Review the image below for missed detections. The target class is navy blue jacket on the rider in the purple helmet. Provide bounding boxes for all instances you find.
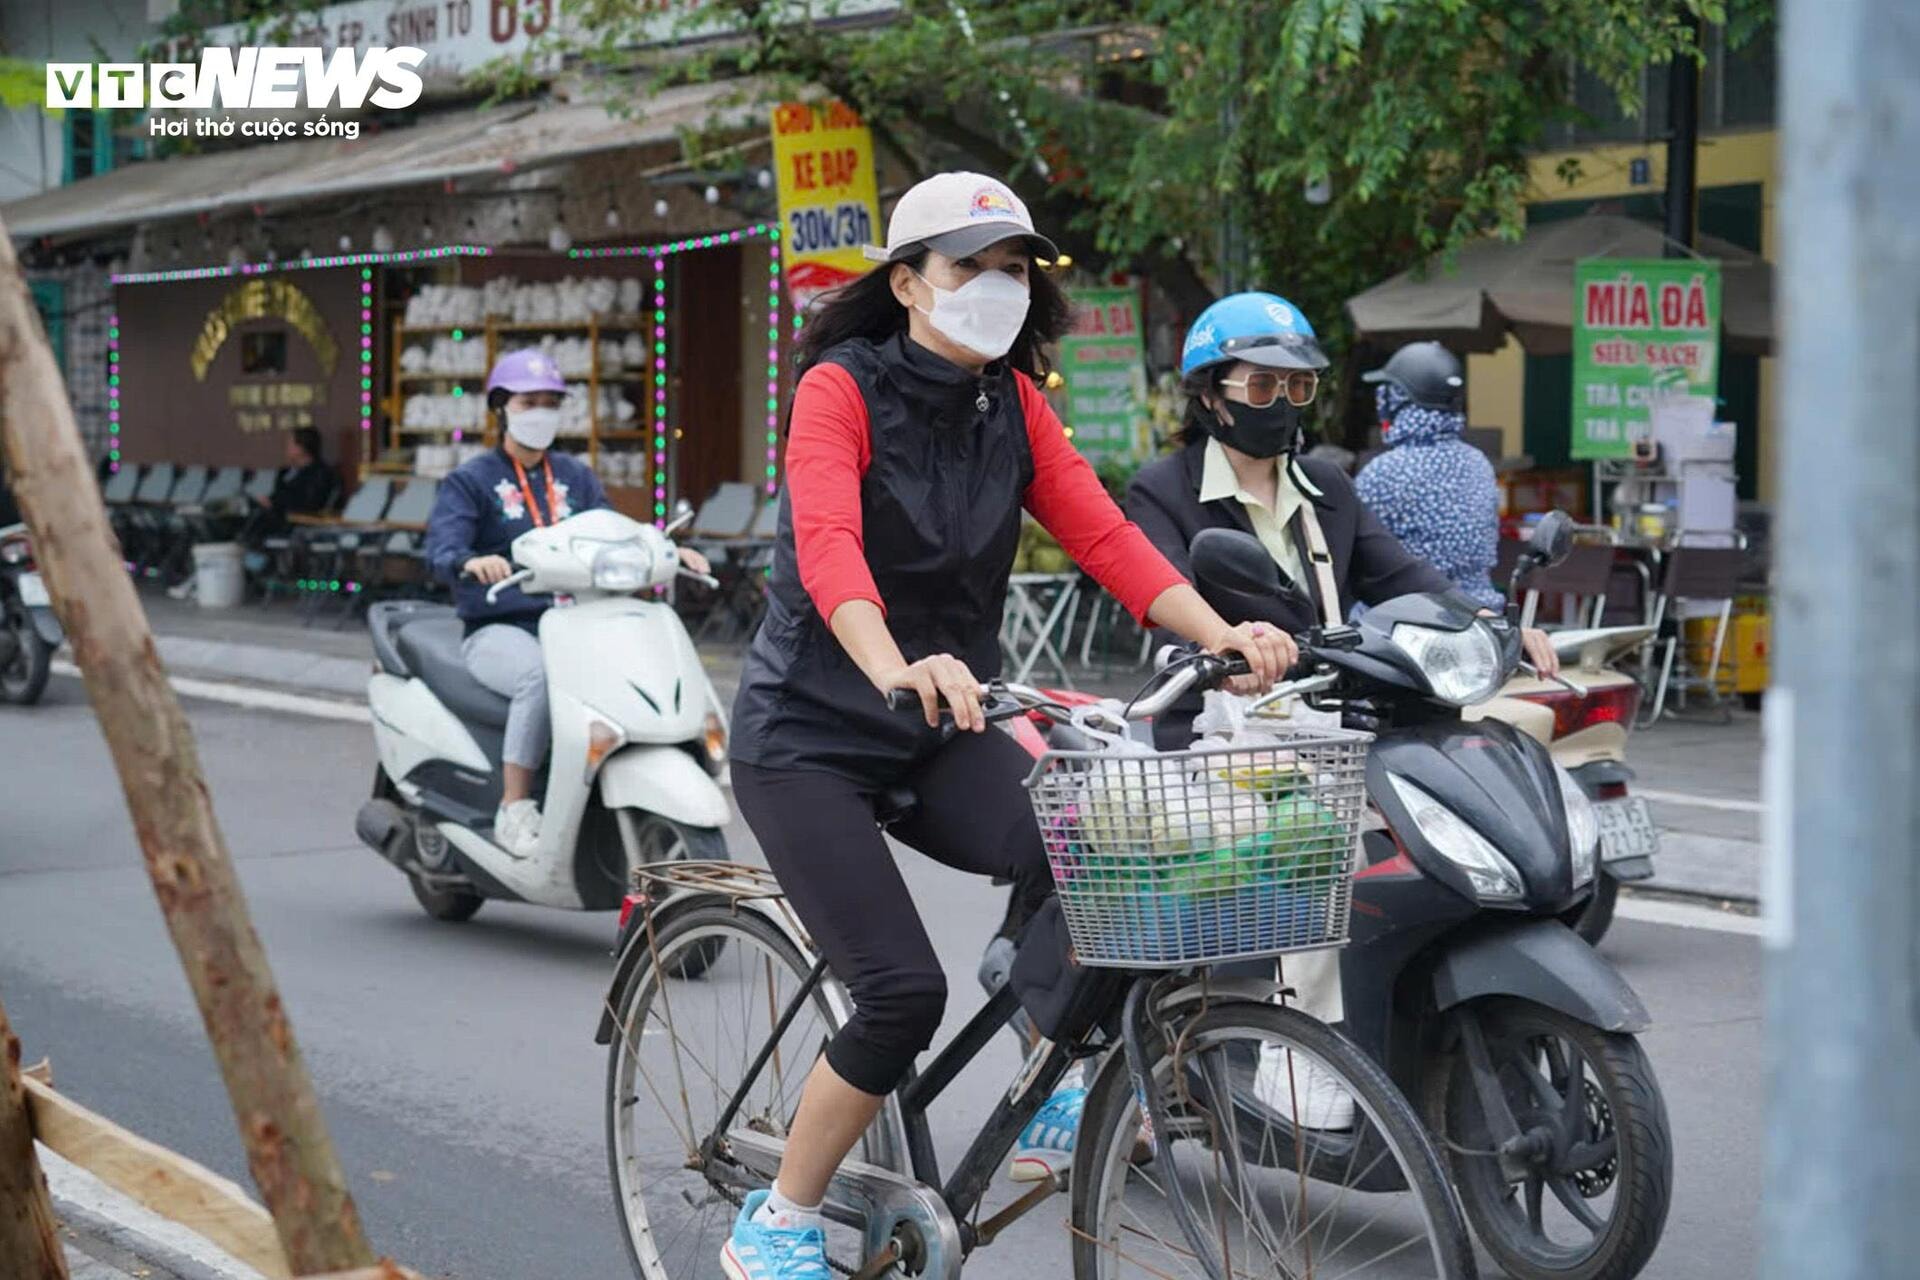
[426,449,607,635]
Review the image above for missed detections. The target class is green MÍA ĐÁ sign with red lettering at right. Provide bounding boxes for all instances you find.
[1572,257,1720,459]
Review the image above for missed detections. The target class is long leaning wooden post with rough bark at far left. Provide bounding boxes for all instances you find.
[0,226,374,1274]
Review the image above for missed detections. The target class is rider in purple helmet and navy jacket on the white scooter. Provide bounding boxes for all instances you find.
[426,351,707,858]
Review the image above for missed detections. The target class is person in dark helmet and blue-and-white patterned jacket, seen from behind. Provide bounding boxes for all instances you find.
[1354,342,1505,608]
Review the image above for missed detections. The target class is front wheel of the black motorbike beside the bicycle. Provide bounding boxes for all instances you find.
[1427,1000,1672,1280]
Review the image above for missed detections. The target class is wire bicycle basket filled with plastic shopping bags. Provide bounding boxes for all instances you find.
[1027,725,1373,969]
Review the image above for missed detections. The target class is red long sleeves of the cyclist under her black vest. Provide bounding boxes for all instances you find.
[787,365,1187,622]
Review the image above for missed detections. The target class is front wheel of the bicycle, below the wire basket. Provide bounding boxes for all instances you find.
[1071,1002,1475,1280]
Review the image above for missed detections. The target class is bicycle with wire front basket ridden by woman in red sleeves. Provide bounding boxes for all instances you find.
[597,654,1476,1280]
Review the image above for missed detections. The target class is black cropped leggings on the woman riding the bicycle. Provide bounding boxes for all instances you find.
[733,729,1054,1094]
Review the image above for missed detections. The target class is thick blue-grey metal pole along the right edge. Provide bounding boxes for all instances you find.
[1761,0,1920,1280]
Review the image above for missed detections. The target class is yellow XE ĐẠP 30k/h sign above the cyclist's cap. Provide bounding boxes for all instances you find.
[774,102,881,313]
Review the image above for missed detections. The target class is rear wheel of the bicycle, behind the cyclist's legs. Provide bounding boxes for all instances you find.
[607,904,904,1280]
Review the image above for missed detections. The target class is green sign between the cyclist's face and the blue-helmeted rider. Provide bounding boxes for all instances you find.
[1060,288,1148,462]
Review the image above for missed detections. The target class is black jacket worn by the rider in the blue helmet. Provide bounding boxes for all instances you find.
[1127,439,1453,747]
